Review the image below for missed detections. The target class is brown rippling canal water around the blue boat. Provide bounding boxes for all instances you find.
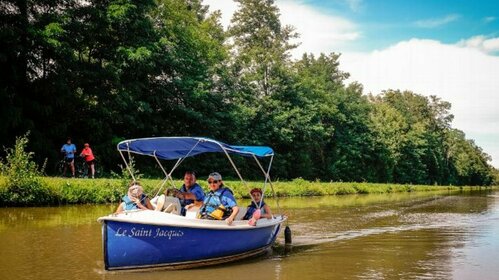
[0,190,499,280]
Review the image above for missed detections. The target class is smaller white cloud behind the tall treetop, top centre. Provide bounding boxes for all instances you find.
[203,0,361,57]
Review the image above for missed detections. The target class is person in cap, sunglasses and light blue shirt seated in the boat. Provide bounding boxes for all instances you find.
[199,172,239,225]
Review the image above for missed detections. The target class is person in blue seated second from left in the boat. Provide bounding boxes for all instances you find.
[155,171,204,216]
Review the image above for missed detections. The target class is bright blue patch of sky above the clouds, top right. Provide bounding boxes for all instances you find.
[296,0,499,54]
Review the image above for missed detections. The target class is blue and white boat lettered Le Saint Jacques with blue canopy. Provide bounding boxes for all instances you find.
[98,137,287,270]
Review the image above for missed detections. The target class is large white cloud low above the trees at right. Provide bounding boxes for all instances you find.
[341,39,499,167]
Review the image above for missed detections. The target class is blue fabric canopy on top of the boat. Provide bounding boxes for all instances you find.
[118,137,274,160]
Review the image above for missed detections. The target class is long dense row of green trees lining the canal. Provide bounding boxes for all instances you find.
[0,0,497,185]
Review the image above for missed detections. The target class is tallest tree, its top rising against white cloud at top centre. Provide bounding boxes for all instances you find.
[228,0,297,98]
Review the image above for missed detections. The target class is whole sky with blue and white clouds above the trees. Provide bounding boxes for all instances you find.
[204,0,499,168]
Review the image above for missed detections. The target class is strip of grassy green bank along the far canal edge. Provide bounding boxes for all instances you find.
[0,176,496,206]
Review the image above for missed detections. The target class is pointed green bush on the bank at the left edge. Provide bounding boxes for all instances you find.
[0,133,53,205]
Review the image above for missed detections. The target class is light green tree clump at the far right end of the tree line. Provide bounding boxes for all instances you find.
[371,90,491,185]
